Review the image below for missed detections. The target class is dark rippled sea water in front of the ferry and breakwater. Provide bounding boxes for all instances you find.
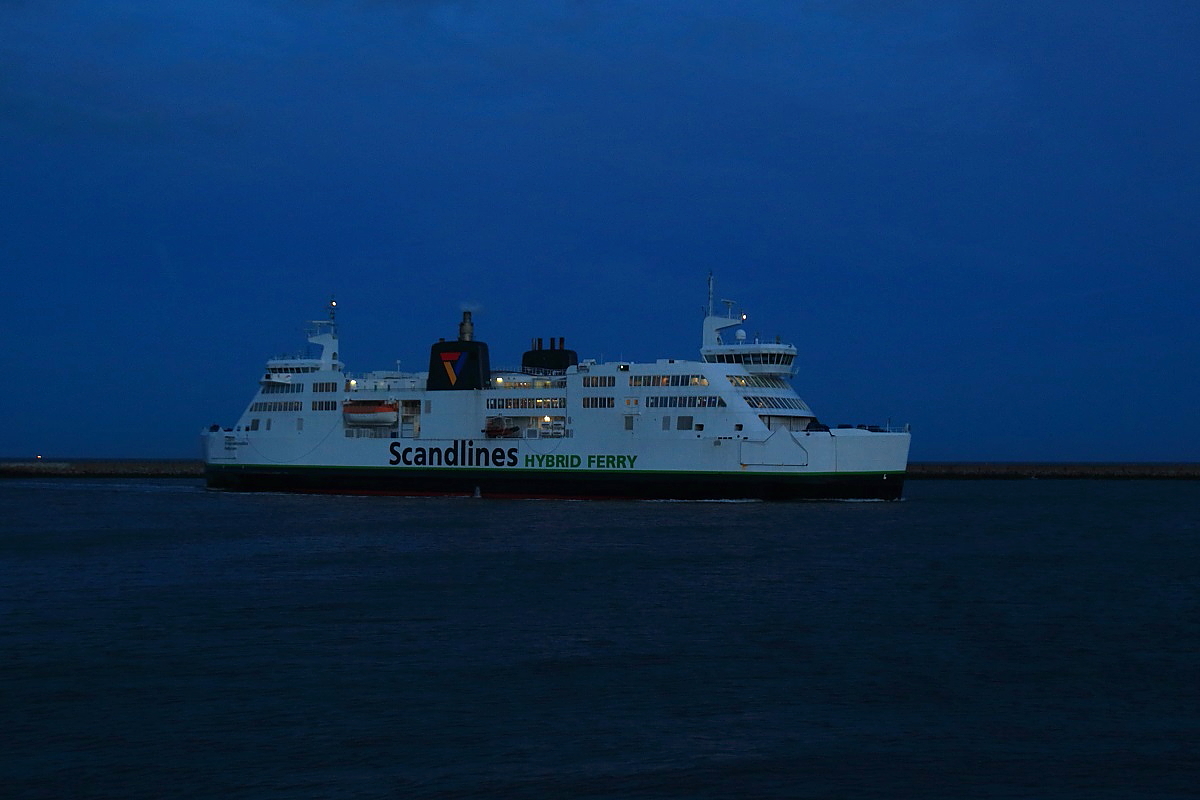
[0,480,1200,800]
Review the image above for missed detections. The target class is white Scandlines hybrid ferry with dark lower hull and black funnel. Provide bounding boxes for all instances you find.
[202,276,910,500]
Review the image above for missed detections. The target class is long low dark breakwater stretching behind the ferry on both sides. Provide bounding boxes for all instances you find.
[0,458,1200,480]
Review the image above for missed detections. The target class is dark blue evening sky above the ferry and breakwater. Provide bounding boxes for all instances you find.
[0,0,1200,461]
